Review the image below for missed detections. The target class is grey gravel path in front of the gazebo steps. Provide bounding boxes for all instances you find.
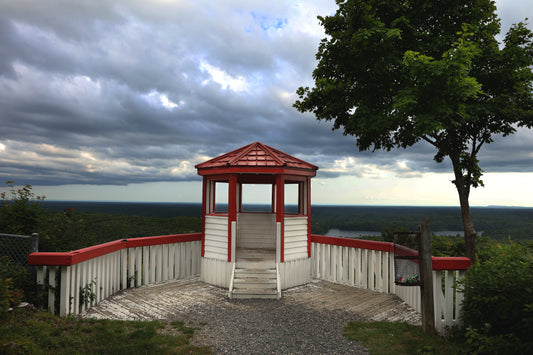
[189,299,367,354]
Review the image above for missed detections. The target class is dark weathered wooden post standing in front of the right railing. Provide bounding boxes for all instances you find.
[420,217,436,334]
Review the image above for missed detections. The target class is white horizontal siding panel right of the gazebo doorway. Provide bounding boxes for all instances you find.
[284,217,308,261]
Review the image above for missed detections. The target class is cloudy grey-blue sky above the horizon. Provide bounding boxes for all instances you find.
[0,0,533,206]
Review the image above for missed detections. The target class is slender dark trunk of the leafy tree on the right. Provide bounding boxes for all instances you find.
[452,158,476,262]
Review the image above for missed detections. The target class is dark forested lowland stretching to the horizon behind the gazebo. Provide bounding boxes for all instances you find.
[44,201,533,240]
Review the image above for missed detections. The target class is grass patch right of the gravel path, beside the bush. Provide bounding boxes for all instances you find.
[344,322,455,355]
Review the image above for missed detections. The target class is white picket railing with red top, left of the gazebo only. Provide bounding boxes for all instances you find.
[28,233,201,316]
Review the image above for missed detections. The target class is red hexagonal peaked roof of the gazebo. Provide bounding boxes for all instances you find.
[195,142,318,176]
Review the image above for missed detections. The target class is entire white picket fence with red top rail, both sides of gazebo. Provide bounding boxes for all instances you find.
[28,233,469,334]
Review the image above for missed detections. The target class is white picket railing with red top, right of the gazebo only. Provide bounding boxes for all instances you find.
[311,235,471,334]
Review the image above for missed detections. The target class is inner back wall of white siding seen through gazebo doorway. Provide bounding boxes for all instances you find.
[237,213,276,249]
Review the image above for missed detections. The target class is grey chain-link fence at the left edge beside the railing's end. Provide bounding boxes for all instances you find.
[0,233,39,266]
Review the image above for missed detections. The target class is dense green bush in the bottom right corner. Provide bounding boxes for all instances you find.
[456,242,533,354]
